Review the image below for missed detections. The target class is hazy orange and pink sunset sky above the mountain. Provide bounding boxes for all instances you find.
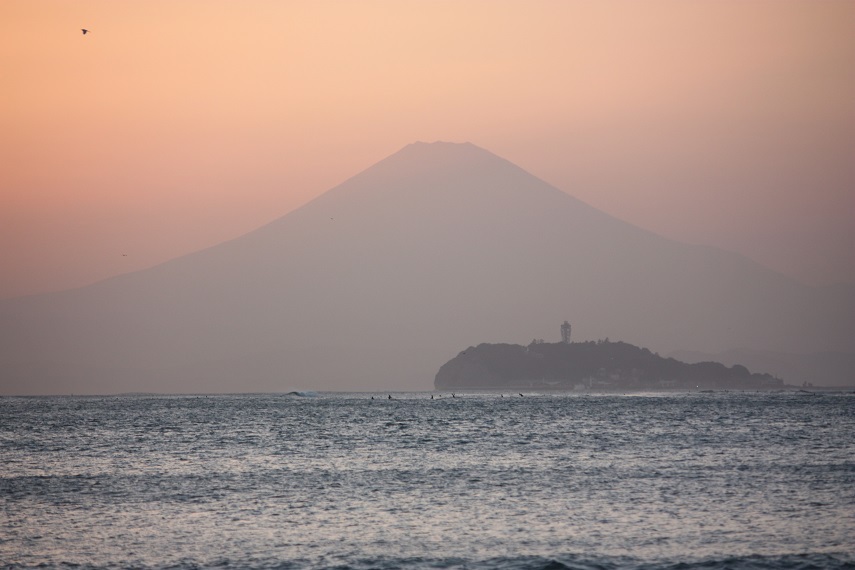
[0,0,855,298]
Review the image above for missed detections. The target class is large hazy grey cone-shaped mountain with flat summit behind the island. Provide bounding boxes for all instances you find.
[0,143,855,393]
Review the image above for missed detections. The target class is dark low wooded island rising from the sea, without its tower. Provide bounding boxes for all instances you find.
[434,340,782,390]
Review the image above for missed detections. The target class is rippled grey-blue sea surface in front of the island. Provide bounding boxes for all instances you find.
[0,392,855,569]
